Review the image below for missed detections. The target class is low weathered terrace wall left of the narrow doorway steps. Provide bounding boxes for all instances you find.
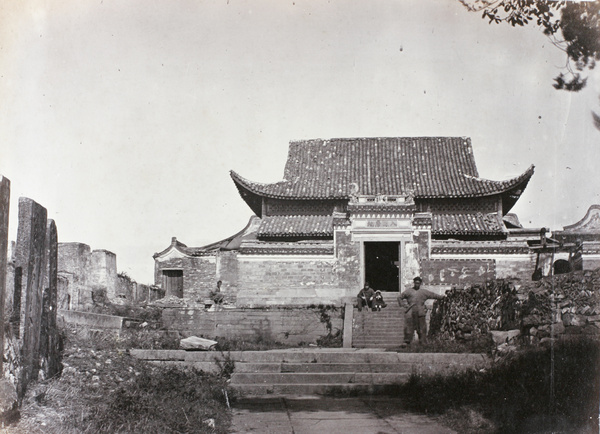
[163,308,343,345]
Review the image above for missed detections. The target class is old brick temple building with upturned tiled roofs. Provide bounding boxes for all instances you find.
[154,137,539,306]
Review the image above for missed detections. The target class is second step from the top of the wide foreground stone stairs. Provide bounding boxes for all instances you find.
[235,363,413,373]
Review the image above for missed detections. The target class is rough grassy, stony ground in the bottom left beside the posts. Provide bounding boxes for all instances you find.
[3,328,231,434]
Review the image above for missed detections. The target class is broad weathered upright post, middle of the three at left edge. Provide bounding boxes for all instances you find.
[15,197,47,399]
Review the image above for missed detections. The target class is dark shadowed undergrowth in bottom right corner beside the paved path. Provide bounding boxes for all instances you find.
[398,339,600,432]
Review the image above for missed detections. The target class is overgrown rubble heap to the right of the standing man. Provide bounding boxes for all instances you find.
[430,269,600,341]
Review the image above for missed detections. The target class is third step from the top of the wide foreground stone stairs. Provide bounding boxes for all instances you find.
[230,372,410,386]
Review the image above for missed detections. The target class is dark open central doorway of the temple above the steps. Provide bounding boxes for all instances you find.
[365,242,400,292]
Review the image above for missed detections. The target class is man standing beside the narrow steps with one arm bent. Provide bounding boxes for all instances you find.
[398,276,444,345]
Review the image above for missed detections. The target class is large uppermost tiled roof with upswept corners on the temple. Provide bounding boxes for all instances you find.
[231,137,533,199]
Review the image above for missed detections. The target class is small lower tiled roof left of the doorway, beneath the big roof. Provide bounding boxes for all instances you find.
[256,215,333,238]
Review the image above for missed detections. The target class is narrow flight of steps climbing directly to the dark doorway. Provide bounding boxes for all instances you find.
[352,292,404,349]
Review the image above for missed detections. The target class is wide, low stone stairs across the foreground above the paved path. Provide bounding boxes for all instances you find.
[131,348,489,396]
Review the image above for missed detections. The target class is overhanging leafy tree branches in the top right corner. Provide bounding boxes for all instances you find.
[460,0,600,92]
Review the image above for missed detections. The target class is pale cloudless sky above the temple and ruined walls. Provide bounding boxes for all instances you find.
[0,0,600,283]
